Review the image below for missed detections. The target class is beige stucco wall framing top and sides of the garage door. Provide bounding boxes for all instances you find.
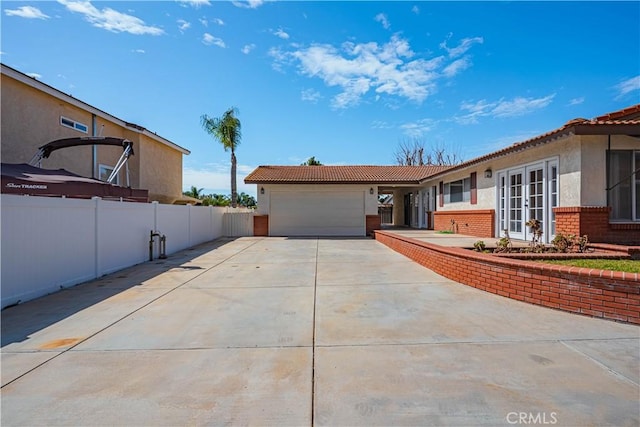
[256,184,378,215]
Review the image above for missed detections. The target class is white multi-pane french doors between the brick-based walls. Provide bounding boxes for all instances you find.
[498,160,558,243]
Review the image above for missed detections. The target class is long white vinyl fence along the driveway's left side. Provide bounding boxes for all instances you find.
[0,194,253,308]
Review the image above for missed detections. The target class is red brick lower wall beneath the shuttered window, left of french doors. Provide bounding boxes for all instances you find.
[433,209,496,237]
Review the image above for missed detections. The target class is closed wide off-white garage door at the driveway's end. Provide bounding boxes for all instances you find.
[269,191,365,236]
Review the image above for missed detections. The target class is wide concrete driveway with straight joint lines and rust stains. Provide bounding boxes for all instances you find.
[0,238,640,426]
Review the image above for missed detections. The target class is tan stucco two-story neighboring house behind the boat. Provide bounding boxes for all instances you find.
[0,64,189,203]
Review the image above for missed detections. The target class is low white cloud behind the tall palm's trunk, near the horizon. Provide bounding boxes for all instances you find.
[182,163,256,196]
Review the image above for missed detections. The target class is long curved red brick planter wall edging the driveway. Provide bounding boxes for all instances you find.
[375,231,640,324]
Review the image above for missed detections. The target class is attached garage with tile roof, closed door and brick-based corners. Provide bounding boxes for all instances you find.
[245,166,444,236]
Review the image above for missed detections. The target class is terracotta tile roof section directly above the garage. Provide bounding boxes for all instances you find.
[244,166,450,184]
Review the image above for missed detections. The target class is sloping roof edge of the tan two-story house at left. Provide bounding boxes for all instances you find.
[1,64,191,154]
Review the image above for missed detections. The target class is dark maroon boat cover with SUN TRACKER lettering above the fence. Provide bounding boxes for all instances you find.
[1,164,149,203]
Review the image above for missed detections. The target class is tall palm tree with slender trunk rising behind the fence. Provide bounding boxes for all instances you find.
[200,107,242,208]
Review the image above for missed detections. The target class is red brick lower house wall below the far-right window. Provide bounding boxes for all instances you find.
[553,206,640,245]
